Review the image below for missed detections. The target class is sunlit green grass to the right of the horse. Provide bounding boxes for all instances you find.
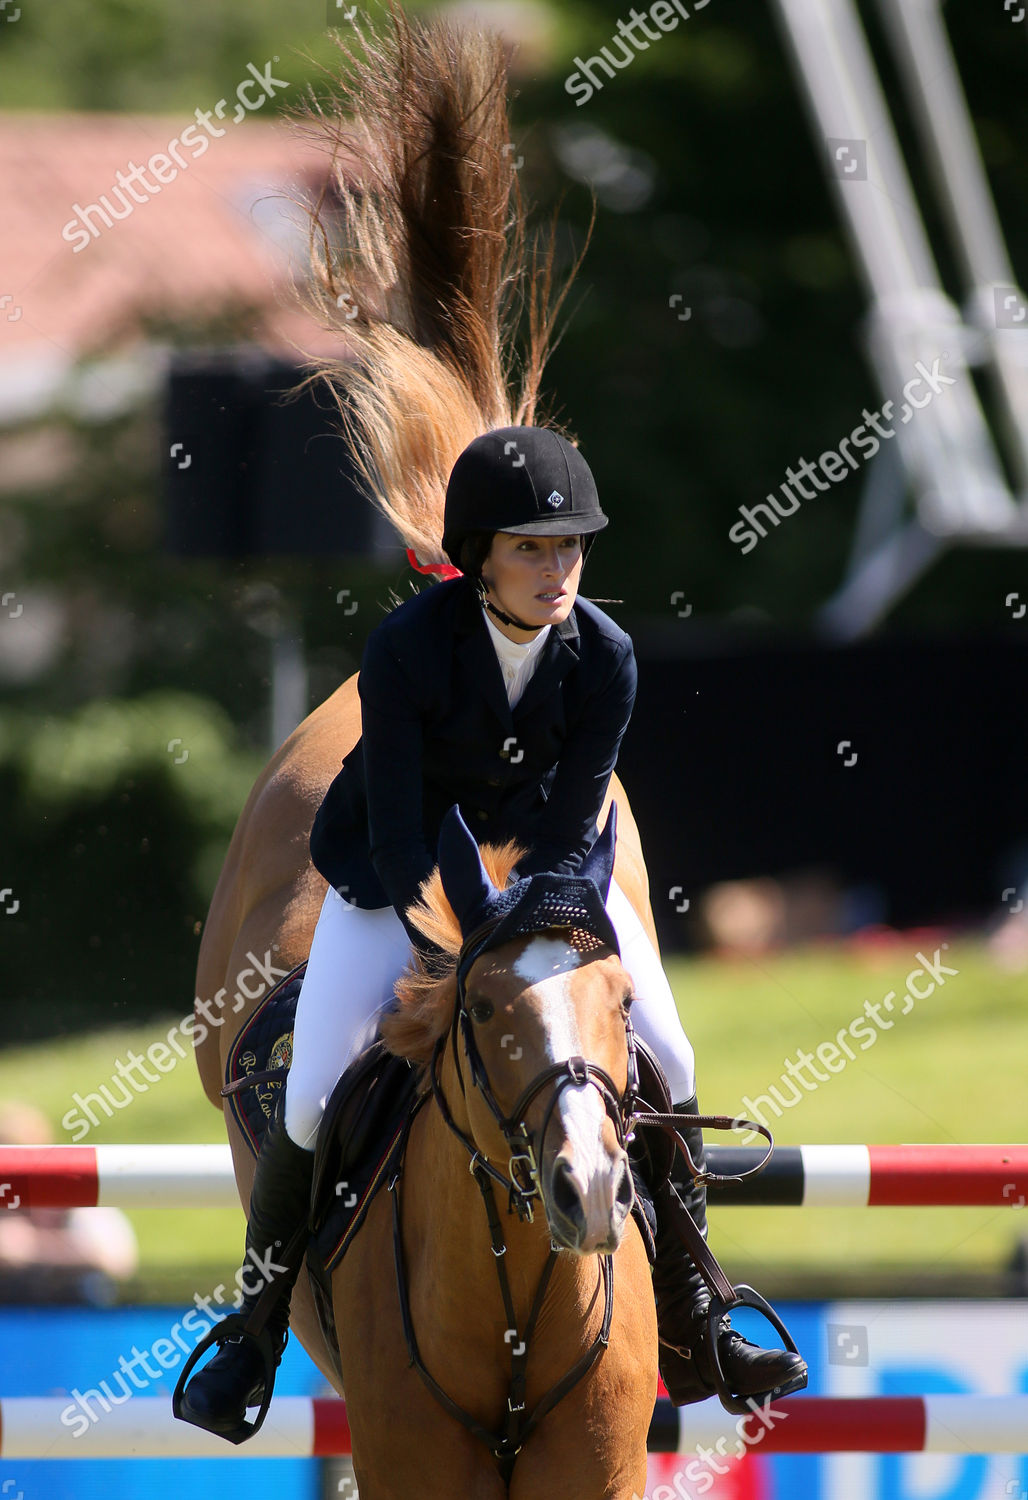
[671,936,1028,1280]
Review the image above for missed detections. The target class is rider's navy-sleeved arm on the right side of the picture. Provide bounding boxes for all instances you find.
[518,636,638,875]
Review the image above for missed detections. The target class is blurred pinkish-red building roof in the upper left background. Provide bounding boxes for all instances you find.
[0,113,348,422]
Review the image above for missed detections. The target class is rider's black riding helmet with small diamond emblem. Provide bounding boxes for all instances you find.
[443,428,606,569]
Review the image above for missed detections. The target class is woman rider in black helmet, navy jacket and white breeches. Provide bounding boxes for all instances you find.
[174,426,804,1434]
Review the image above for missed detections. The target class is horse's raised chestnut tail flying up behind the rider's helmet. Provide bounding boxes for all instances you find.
[297,0,591,563]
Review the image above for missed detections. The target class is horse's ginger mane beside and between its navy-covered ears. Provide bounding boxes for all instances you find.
[381,842,525,1065]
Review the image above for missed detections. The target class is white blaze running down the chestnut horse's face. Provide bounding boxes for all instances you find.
[513,938,621,1242]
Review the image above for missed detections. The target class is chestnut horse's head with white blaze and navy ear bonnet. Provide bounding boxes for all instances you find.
[438,807,636,1254]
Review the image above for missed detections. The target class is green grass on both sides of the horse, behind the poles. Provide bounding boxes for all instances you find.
[0,936,1028,1295]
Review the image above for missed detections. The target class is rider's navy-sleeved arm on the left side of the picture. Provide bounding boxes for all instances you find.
[357,633,435,953]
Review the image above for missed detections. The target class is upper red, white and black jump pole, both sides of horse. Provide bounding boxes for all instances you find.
[0,1145,1028,1209]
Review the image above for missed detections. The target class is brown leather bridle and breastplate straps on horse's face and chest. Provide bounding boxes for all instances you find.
[389,920,639,1482]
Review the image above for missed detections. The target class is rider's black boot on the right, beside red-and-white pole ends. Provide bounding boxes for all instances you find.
[653,1095,807,1406]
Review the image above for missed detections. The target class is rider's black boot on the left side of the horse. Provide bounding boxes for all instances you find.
[176,1103,314,1442]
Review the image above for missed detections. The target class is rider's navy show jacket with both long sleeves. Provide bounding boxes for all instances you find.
[311,578,636,947]
